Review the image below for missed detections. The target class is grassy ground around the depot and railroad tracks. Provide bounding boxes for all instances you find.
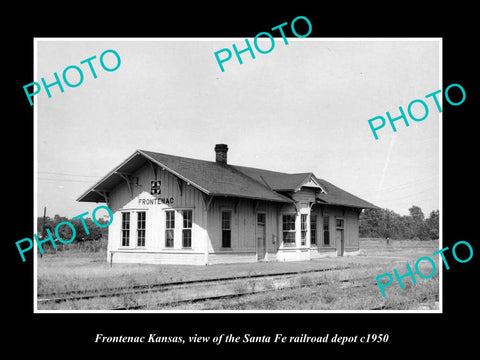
[37,239,439,310]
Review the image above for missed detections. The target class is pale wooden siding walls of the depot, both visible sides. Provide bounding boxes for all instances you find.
[107,164,359,264]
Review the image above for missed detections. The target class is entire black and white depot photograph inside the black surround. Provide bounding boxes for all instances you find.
[32,37,438,313]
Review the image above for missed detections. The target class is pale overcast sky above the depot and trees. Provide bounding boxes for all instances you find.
[32,38,441,217]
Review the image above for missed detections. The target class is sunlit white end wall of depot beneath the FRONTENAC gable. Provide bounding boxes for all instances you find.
[107,164,208,263]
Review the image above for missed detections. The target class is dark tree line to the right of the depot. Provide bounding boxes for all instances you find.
[359,205,439,240]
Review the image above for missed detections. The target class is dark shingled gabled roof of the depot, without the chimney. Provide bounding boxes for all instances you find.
[77,150,377,208]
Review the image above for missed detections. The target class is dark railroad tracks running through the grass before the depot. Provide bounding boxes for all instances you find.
[37,266,351,304]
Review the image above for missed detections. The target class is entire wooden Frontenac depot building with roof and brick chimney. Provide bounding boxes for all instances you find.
[77,144,376,265]
